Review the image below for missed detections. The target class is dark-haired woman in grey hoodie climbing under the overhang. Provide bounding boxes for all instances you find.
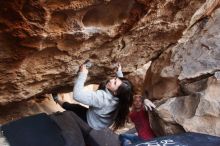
[53,64,133,130]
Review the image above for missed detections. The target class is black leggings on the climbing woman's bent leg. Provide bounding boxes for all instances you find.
[62,102,88,123]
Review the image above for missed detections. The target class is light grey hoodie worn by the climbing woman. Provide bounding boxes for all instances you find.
[73,71,123,130]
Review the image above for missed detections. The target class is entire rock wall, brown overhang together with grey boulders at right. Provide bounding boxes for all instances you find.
[0,0,220,138]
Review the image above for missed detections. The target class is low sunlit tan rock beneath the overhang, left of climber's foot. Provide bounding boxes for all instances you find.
[0,96,64,125]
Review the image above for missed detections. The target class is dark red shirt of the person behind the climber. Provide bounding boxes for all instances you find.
[129,108,155,140]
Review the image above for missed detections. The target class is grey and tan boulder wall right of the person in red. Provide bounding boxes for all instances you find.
[145,0,220,136]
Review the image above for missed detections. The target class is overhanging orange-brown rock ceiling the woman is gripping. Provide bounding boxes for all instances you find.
[0,0,204,104]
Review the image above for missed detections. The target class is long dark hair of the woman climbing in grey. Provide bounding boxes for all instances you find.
[113,78,133,130]
